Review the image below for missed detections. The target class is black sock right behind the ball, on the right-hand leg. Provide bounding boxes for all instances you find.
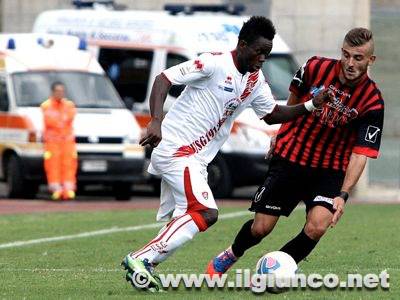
[280,228,318,263]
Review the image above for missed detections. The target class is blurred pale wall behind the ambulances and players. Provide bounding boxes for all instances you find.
[0,0,400,193]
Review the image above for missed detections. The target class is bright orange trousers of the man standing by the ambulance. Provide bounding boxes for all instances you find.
[44,141,78,192]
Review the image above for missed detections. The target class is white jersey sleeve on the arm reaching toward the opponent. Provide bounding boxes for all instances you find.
[250,76,276,119]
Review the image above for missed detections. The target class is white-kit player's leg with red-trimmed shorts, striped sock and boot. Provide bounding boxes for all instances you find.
[123,164,218,290]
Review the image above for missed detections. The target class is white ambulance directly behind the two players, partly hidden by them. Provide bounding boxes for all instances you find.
[33,1,297,197]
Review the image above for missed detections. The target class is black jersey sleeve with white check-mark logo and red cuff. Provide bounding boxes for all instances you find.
[353,109,384,158]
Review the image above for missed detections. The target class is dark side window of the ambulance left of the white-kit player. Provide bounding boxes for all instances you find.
[99,48,153,104]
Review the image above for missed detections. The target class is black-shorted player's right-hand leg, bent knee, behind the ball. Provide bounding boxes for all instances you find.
[280,170,344,263]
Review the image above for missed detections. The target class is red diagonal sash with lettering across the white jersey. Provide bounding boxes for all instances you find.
[173,72,258,157]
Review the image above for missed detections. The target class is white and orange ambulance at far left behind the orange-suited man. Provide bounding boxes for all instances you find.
[0,33,145,200]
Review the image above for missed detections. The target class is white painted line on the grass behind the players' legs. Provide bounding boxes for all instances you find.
[0,211,250,249]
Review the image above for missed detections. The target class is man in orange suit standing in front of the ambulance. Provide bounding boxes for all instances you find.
[41,82,78,200]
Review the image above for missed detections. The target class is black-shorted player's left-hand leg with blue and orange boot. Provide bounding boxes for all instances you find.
[206,159,299,274]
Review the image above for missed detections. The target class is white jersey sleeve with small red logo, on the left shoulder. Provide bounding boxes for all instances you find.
[163,53,216,86]
